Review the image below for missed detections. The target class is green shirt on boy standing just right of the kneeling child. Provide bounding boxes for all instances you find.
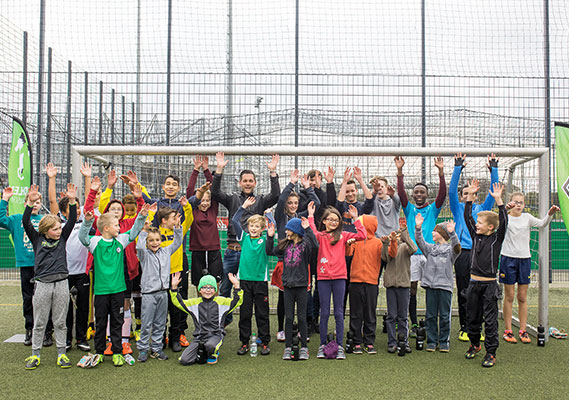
[238,232,269,282]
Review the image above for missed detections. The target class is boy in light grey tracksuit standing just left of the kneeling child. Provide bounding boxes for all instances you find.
[136,227,183,362]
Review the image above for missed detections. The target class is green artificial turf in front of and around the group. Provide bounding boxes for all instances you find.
[0,283,569,399]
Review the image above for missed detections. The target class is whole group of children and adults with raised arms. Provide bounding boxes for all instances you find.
[0,153,558,369]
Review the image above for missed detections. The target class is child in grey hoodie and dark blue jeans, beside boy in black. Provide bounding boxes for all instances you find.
[415,214,461,353]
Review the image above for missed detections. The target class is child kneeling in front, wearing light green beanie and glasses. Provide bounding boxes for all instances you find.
[170,272,243,365]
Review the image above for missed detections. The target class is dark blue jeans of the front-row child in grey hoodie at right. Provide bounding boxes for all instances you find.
[425,288,452,349]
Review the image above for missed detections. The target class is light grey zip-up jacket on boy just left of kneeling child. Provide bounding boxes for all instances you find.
[136,228,183,294]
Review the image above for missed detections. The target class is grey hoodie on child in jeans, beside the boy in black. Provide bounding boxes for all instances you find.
[415,226,460,292]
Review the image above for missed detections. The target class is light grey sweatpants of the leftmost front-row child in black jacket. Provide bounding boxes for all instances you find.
[32,279,69,356]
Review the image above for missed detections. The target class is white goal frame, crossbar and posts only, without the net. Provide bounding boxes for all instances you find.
[71,145,551,334]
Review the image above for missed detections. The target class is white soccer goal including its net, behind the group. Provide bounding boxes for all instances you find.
[72,143,560,340]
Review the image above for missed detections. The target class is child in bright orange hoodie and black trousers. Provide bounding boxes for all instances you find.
[348,215,397,354]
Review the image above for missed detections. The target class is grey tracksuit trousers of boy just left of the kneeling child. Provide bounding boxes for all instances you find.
[136,290,168,351]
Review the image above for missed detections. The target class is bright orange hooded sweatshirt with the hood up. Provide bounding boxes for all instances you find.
[350,215,397,285]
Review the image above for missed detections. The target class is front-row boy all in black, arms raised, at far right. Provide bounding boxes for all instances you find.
[463,179,508,367]
